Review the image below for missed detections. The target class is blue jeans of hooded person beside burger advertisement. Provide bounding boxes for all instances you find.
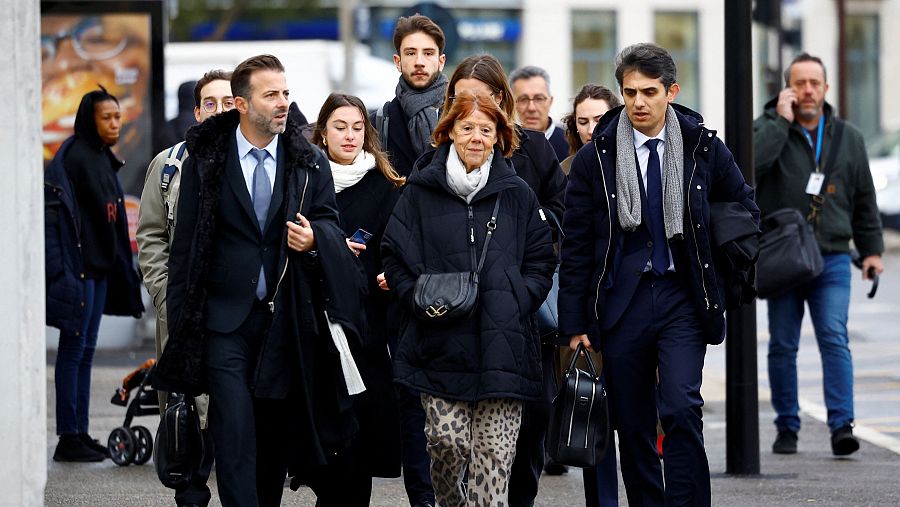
[54,278,106,435]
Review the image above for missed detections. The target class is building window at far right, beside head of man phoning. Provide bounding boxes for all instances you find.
[848,14,881,137]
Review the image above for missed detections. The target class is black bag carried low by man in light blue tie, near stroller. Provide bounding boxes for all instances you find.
[153,393,205,489]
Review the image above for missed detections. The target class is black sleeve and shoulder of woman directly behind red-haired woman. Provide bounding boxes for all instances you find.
[510,127,566,221]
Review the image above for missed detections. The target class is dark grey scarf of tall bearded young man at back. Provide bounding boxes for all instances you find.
[397,74,448,155]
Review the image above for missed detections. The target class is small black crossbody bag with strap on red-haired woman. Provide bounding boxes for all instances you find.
[413,192,503,322]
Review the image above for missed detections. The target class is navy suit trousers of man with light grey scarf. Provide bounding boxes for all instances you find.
[600,273,711,507]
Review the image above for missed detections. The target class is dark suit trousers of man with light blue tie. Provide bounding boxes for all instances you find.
[206,303,289,507]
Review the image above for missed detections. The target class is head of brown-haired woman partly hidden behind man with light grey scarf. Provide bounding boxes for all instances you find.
[559,83,622,175]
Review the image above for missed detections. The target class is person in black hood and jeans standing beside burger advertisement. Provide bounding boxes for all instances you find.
[44,88,144,461]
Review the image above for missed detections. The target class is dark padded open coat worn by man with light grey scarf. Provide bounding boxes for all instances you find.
[558,105,759,344]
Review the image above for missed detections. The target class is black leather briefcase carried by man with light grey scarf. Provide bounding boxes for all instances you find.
[547,344,609,468]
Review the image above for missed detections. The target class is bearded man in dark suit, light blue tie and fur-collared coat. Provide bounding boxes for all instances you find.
[154,55,364,507]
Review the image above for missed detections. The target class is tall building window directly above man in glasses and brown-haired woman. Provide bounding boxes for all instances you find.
[572,10,619,96]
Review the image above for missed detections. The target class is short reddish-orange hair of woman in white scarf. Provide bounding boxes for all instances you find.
[431,90,519,158]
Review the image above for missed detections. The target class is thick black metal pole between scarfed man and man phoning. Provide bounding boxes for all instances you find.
[725,0,759,475]
